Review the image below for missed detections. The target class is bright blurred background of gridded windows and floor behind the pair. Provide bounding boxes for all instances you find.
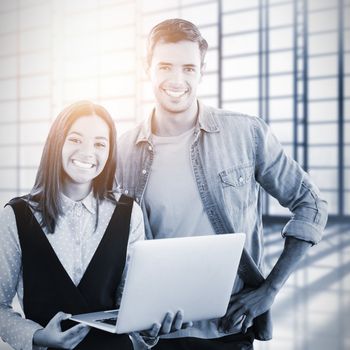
[0,0,350,350]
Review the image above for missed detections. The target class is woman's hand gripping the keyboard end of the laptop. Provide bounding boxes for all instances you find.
[33,312,90,349]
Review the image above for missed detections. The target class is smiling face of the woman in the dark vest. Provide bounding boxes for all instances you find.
[62,115,110,190]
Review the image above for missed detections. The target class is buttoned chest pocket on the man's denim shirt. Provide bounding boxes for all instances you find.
[219,164,255,212]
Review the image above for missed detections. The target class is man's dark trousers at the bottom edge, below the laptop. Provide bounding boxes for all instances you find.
[153,329,254,350]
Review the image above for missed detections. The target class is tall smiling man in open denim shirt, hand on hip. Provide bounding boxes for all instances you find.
[117,19,327,350]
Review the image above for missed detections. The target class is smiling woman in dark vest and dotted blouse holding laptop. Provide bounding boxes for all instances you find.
[0,101,182,349]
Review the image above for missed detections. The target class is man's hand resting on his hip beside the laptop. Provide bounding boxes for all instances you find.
[220,284,277,333]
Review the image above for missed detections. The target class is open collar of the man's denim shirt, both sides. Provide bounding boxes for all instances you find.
[136,100,220,144]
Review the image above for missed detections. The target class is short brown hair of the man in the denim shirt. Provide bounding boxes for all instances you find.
[147,18,208,67]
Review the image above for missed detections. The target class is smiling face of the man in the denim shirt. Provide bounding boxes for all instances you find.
[149,40,202,113]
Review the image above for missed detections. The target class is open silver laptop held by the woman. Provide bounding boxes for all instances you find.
[71,233,245,333]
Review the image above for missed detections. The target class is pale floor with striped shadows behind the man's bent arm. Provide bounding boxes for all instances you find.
[0,223,350,350]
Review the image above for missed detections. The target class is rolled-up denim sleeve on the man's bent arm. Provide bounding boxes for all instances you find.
[255,118,327,244]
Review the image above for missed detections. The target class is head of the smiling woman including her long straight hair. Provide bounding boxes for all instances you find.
[29,101,116,232]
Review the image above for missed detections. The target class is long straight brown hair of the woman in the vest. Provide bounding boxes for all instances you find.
[28,101,117,233]
